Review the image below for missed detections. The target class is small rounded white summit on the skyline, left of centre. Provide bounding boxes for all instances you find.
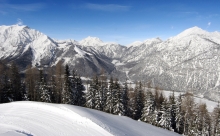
[79,36,103,46]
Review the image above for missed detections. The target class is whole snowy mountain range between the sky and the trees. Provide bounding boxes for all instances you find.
[0,25,220,100]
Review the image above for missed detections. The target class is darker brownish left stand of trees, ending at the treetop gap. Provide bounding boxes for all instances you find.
[0,62,85,106]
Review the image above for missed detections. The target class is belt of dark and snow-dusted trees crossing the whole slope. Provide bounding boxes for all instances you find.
[0,62,220,136]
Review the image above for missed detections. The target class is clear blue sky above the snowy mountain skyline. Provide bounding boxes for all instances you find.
[0,0,220,45]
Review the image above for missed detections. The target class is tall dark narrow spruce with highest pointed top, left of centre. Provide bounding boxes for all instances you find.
[61,65,73,104]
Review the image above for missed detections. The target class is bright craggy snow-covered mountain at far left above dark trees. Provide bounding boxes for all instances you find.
[0,25,57,65]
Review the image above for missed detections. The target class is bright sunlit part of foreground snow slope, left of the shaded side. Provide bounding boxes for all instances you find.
[0,102,111,136]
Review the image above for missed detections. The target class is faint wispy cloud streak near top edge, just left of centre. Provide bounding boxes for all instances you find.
[84,3,130,11]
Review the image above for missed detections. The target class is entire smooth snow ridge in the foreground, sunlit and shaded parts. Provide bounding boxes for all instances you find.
[0,102,178,136]
